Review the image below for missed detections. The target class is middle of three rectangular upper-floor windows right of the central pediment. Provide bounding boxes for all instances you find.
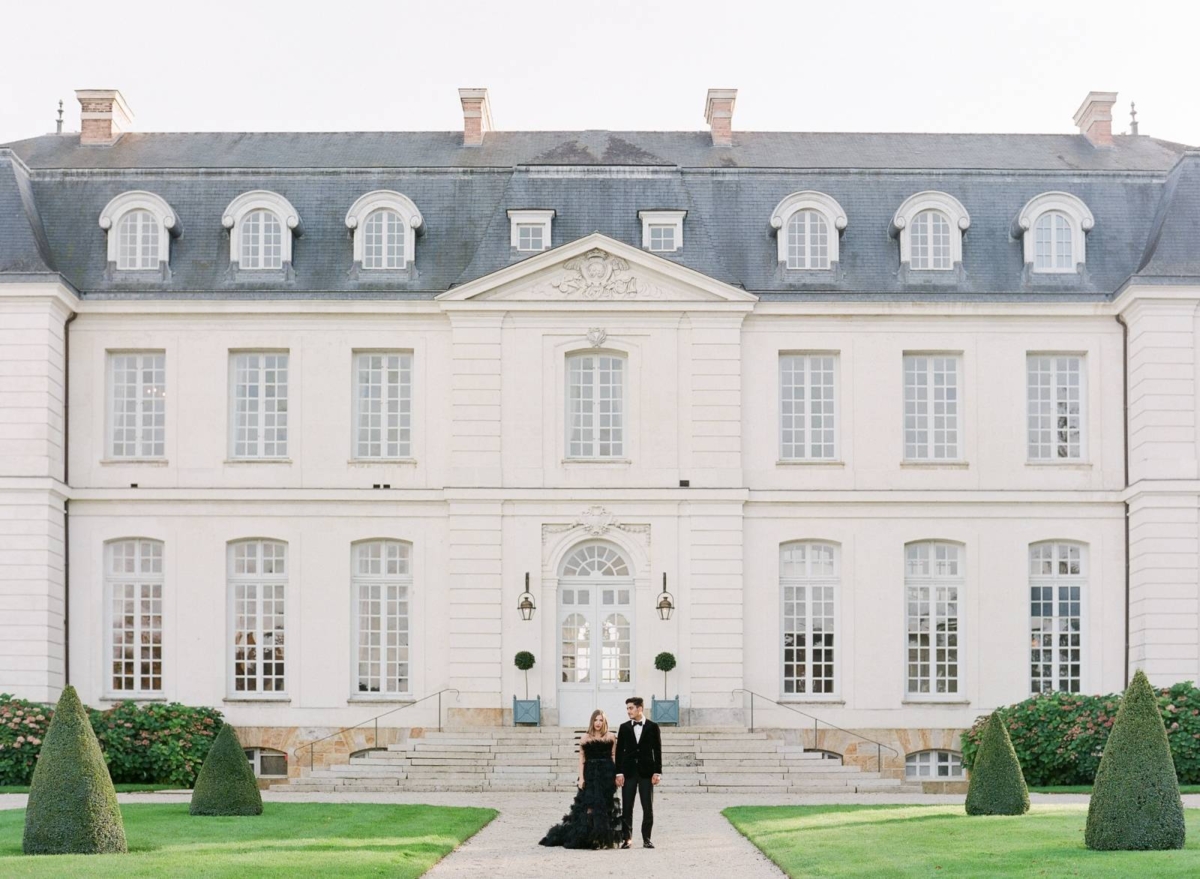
[904,354,961,461]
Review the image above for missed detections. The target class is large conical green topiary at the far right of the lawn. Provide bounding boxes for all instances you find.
[1084,669,1184,851]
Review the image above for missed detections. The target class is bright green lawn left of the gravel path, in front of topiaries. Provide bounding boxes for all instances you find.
[0,802,496,879]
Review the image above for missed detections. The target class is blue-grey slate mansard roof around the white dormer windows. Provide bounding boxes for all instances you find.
[0,131,1200,299]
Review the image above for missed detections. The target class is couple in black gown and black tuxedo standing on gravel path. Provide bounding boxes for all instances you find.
[540,696,662,849]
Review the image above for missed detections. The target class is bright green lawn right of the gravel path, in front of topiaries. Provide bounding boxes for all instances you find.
[724,805,1200,879]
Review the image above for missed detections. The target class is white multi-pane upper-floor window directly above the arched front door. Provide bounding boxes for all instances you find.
[566,354,625,458]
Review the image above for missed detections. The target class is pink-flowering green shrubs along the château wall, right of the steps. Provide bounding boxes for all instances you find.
[962,681,1200,785]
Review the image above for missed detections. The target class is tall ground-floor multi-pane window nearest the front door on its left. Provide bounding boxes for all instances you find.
[354,540,413,694]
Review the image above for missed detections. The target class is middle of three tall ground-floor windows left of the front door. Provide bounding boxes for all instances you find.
[229,540,288,695]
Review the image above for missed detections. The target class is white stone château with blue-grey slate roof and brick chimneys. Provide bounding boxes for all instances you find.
[0,89,1200,778]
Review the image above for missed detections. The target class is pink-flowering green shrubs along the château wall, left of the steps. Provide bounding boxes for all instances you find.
[0,693,222,788]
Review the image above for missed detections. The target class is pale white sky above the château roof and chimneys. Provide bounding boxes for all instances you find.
[0,0,1200,145]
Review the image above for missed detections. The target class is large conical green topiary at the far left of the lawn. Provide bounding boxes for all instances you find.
[22,687,128,855]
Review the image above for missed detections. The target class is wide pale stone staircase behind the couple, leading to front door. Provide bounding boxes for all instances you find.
[278,726,920,794]
